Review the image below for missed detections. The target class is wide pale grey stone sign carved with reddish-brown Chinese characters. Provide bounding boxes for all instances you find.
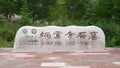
[14,26,105,50]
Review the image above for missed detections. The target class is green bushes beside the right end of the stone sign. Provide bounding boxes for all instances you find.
[96,22,120,47]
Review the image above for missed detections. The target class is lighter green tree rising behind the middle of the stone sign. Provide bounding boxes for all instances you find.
[48,0,68,26]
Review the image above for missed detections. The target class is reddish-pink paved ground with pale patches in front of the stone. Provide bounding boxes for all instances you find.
[0,48,120,68]
